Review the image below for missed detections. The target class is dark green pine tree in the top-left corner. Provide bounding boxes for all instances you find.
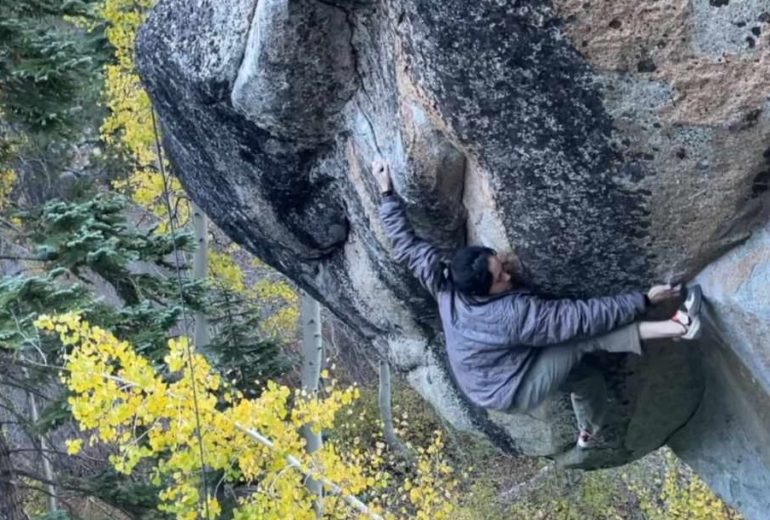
[0,0,109,212]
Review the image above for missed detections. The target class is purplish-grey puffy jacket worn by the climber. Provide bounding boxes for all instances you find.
[380,195,645,410]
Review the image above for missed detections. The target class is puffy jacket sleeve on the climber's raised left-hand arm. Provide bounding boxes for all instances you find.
[380,195,442,297]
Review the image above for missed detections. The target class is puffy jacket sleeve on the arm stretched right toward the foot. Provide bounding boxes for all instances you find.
[511,292,646,347]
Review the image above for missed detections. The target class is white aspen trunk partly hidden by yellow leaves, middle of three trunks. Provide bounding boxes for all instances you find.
[300,291,323,518]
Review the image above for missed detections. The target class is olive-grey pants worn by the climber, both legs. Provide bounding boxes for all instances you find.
[511,323,642,432]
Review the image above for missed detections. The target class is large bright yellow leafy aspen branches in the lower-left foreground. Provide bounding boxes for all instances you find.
[35,313,456,520]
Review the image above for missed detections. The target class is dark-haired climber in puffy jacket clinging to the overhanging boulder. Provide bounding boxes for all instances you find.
[372,160,701,448]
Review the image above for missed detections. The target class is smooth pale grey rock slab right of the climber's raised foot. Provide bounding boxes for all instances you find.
[669,225,770,519]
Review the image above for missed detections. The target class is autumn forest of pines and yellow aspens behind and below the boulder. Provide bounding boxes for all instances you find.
[0,0,738,520]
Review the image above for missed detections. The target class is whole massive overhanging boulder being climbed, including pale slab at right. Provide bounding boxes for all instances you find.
[137,0,770,518]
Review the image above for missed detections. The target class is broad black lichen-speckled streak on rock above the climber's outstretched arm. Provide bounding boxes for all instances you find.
[401,0,647,295]
